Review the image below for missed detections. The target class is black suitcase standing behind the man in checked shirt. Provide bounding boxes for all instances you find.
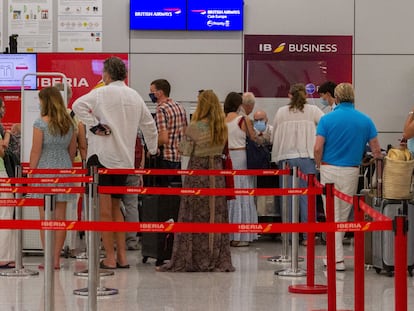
[139,157,181,266]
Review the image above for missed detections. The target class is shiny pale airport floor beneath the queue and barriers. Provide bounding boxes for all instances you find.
[0,236,414,311]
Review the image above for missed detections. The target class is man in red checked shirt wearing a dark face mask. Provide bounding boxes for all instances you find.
[149,79,187,186]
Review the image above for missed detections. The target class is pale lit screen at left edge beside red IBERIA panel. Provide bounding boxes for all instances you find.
[0,54,37,91]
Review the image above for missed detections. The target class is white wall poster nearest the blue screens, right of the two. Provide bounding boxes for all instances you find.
[58,0,103,52]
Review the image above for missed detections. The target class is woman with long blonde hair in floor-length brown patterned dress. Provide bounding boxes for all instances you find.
[156,90,234,272]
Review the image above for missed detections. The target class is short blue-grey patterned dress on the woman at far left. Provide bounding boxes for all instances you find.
[32,118,76,202]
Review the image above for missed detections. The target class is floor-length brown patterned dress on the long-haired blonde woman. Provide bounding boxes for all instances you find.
[160,121,235,272]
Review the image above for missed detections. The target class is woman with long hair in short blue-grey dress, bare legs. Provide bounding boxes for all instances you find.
[30,87,76,269]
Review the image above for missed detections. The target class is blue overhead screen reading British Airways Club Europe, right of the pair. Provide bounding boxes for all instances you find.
[187,0,243,31]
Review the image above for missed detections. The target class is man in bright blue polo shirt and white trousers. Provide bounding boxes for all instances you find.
[314,83,382,271]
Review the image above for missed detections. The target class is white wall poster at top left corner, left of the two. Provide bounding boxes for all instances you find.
[7,0,53,53]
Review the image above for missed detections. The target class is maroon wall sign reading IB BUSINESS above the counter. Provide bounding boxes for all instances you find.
[244,35,352,97]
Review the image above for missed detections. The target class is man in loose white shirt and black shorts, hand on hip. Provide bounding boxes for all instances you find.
[72,57,158,269]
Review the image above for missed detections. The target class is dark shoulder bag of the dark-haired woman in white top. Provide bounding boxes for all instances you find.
[239,117,270,169]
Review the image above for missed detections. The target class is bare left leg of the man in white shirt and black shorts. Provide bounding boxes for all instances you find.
[99,193,116,267]
